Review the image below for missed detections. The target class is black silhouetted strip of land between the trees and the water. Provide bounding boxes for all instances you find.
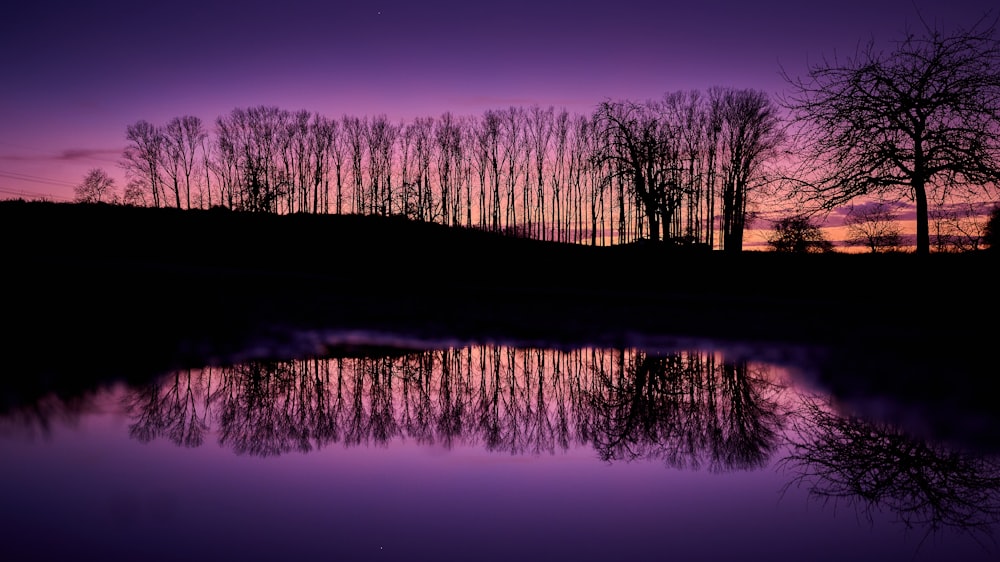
[0,202,998,434]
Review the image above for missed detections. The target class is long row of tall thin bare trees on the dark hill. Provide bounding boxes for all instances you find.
[123,88,780,246]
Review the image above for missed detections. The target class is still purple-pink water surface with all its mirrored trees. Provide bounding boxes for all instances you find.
[0,336,1000,561]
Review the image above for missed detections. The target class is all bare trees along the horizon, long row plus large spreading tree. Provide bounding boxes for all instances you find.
[107,15,1000,253]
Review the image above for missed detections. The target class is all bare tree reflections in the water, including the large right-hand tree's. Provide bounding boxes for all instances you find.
[6,345,1000,543]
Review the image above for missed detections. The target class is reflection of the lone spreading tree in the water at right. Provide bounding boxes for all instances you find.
[781,399,1000,539]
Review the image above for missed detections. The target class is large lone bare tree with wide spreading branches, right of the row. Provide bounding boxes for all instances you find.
[784,13,1000,254]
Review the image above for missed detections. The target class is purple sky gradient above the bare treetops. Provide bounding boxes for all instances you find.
[0,0,996,200]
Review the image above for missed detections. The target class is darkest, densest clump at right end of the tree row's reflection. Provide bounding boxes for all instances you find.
[590,353,782,470]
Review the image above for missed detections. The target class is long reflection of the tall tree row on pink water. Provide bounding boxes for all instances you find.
[121,346,782,470]
